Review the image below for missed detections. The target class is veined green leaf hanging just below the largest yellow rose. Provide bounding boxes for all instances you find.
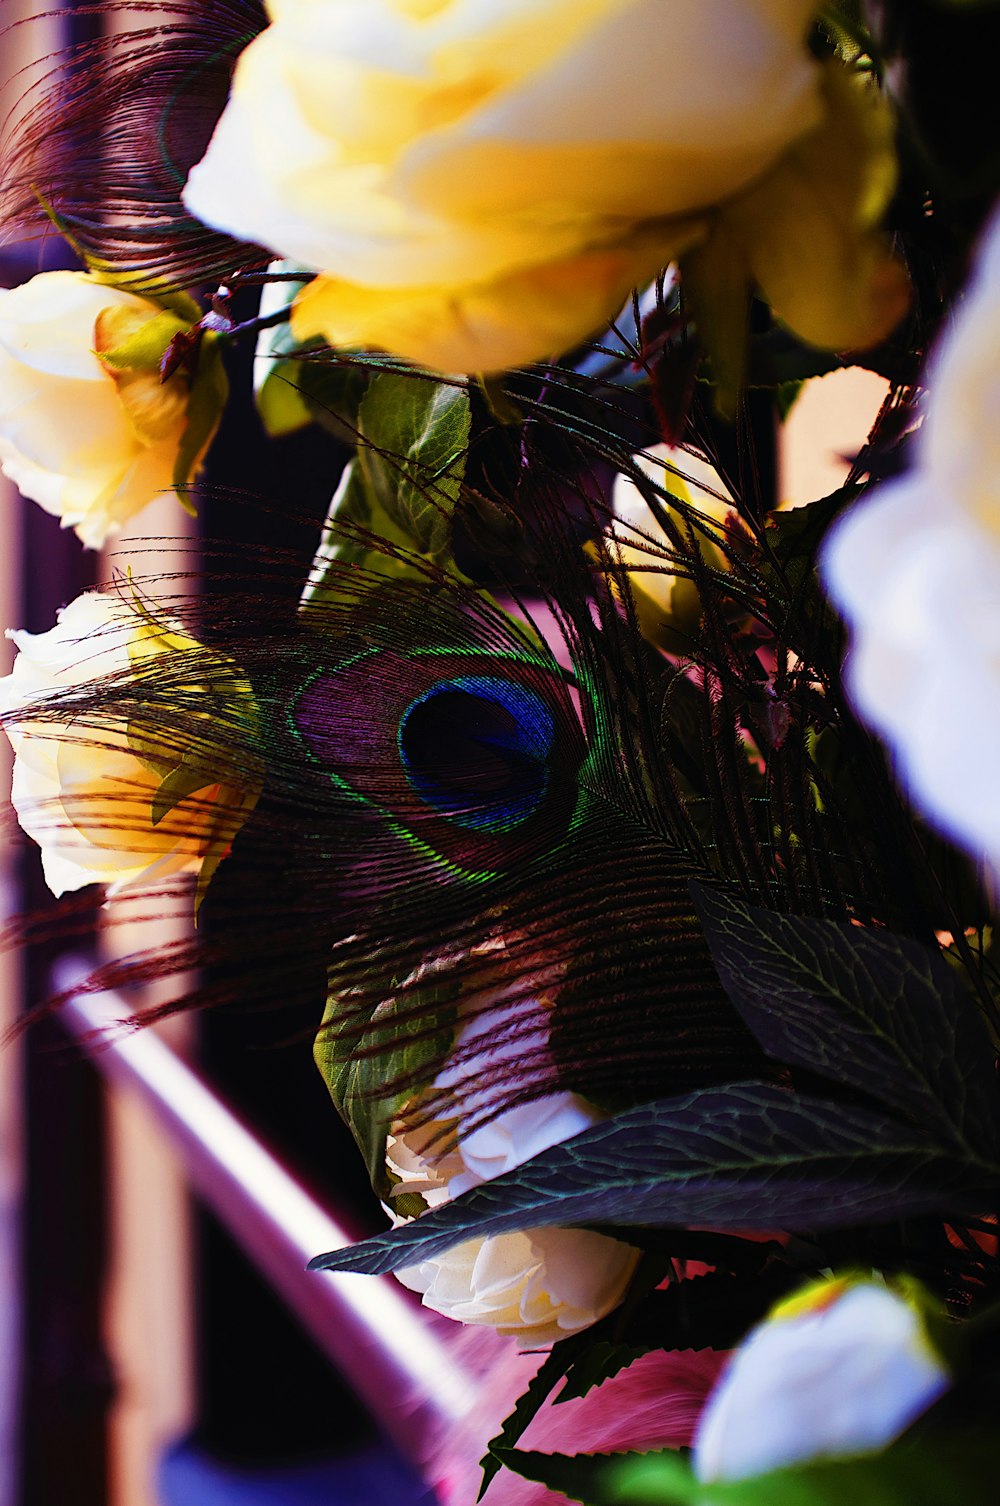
[358,372,470,559]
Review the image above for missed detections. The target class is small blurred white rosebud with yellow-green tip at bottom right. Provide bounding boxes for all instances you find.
[694,1280,952,1480]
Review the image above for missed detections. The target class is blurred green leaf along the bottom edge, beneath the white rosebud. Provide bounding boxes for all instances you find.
[502,1432,1000,1506]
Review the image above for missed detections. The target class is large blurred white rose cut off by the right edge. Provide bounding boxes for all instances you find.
[821,209,1000,872]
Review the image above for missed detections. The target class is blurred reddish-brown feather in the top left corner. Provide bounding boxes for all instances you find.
[0,0,268,291]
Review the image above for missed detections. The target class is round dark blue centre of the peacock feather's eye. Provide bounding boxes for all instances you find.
[399,675,556,831]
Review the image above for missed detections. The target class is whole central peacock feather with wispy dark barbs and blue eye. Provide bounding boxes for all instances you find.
[3,358,993,1117]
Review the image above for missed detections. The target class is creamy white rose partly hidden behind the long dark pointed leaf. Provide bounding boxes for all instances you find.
[386,1006,639,1348]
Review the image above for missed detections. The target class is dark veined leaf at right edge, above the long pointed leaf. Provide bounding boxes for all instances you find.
[691,884,1000,1157]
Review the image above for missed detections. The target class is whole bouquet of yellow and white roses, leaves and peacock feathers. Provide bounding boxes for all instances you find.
[0,0,1000,1506]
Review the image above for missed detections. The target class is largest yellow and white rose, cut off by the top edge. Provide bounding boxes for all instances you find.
[185,0,822,370]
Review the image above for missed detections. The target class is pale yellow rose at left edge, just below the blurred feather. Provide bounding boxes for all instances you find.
[0,273,223,548]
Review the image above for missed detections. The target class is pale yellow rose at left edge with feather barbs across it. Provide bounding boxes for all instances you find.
[0,592,261,895]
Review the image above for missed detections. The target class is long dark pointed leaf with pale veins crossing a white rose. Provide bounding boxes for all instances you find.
[310,1083,1000,1274]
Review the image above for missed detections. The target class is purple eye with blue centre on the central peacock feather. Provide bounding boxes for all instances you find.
[289,646,584,878]
